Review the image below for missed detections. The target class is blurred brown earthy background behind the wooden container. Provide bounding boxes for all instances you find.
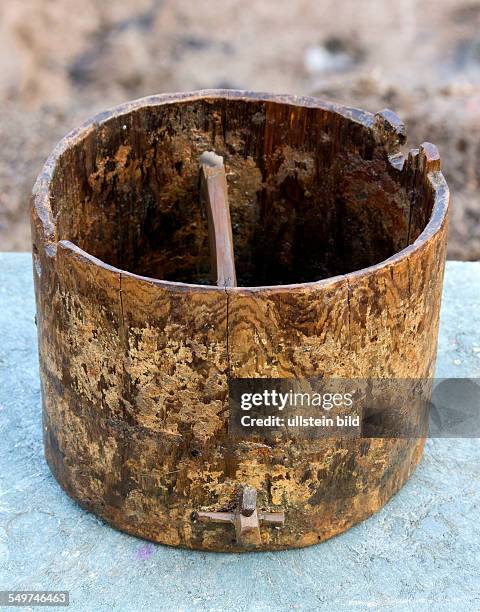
[0,0,480,259]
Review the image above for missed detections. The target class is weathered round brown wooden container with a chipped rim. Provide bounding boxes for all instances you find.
[32,91,449,551]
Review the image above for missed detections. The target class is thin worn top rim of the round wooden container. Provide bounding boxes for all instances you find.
[32,89,450,293]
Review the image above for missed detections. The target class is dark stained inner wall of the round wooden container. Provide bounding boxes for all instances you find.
[52,99,432,286]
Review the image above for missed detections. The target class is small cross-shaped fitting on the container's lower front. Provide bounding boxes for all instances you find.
[196,486,285,547]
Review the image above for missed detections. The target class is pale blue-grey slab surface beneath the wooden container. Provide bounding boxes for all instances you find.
[0,254,480,612]
